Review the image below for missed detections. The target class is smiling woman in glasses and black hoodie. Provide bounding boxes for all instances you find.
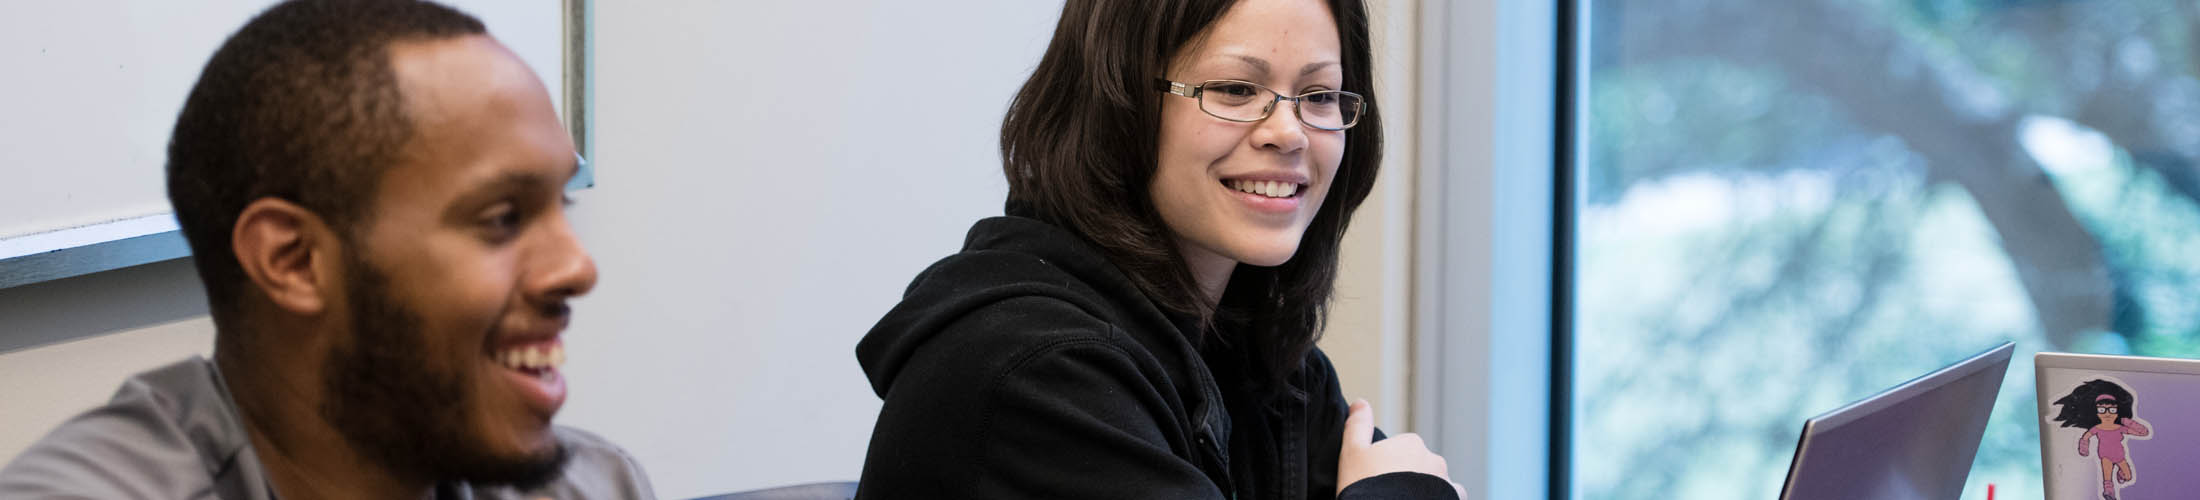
[856,0,1456,498]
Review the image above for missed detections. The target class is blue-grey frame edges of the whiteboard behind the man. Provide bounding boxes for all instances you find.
[0,0,596,289]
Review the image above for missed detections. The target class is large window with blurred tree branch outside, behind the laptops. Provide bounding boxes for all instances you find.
[1566,0,2200,500]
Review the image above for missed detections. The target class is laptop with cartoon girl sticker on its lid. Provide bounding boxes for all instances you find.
[2033,352,2200,500]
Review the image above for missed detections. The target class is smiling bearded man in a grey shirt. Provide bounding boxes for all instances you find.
[0,0,651,500]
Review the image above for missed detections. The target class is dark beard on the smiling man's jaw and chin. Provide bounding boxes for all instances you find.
[321,244,568,489]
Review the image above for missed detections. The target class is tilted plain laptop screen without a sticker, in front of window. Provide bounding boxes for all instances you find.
[1780,341,2015,500]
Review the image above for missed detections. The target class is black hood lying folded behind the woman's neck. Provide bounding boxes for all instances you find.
[856,216,1210,396]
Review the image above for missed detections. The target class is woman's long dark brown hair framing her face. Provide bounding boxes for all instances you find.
[1001,0,1382,398]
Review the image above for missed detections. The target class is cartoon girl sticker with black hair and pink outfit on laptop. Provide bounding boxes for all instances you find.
[2055,379,2152,500]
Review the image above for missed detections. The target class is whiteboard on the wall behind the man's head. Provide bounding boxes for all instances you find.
[0,0,585,286]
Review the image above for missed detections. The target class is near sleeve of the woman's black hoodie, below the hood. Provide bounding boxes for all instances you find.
[858,300,1225,500]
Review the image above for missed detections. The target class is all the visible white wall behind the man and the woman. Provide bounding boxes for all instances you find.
[0,0,1443,498]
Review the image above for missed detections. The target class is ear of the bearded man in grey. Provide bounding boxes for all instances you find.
[229,198,343,315]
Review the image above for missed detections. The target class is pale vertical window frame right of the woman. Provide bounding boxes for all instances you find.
[1410,0,1580,498]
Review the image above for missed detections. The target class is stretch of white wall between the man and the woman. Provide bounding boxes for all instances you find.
[563,0,1060,498]
